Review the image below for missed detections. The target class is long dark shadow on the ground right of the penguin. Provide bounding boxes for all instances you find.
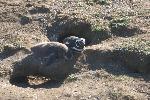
[85,51,150,81]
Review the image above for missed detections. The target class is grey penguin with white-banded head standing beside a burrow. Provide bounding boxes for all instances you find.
[10,36,85,84]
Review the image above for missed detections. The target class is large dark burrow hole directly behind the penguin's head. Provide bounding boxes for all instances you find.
[45,18,110,46]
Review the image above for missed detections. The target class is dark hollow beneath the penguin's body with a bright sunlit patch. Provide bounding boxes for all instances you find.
[9,75,63,89]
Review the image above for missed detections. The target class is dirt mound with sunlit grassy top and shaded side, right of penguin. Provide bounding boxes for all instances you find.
[85,34,150,73]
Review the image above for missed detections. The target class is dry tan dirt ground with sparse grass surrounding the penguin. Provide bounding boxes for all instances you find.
[0,0,150,100]
